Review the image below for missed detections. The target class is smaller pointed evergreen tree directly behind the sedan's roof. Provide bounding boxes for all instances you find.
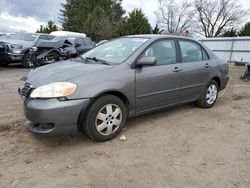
[114,9,151,36]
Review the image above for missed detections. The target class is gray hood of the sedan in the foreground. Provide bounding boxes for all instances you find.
[22,59,112,87]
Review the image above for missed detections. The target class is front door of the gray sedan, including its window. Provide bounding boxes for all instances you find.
[136,39,182,114]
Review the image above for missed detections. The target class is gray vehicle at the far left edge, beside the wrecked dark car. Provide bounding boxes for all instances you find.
[0,33,54,67]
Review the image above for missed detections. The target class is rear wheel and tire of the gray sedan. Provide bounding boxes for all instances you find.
[197,80,219,108]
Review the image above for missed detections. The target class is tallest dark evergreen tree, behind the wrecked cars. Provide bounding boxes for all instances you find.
[59,0,125,33]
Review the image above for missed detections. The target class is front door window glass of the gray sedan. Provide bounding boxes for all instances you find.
[143,40,176,65]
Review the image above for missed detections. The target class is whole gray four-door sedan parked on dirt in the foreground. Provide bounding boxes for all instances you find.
[19,35,229,141]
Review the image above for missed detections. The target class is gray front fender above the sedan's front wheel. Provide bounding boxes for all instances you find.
[68,65,135,111]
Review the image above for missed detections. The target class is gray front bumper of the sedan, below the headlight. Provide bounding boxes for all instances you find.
[24,97,90,135]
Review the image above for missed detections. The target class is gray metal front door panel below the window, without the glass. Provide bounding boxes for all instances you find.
[136,63,182,113]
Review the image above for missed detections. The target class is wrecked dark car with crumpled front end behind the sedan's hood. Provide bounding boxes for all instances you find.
[29,35,95,67]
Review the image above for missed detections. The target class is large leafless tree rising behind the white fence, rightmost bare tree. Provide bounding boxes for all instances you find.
[194,0,247,37]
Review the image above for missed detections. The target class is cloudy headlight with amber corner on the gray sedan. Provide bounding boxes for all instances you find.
[30,82,77,98]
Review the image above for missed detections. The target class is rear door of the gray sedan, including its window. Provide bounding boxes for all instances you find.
[178,39,211,101]
